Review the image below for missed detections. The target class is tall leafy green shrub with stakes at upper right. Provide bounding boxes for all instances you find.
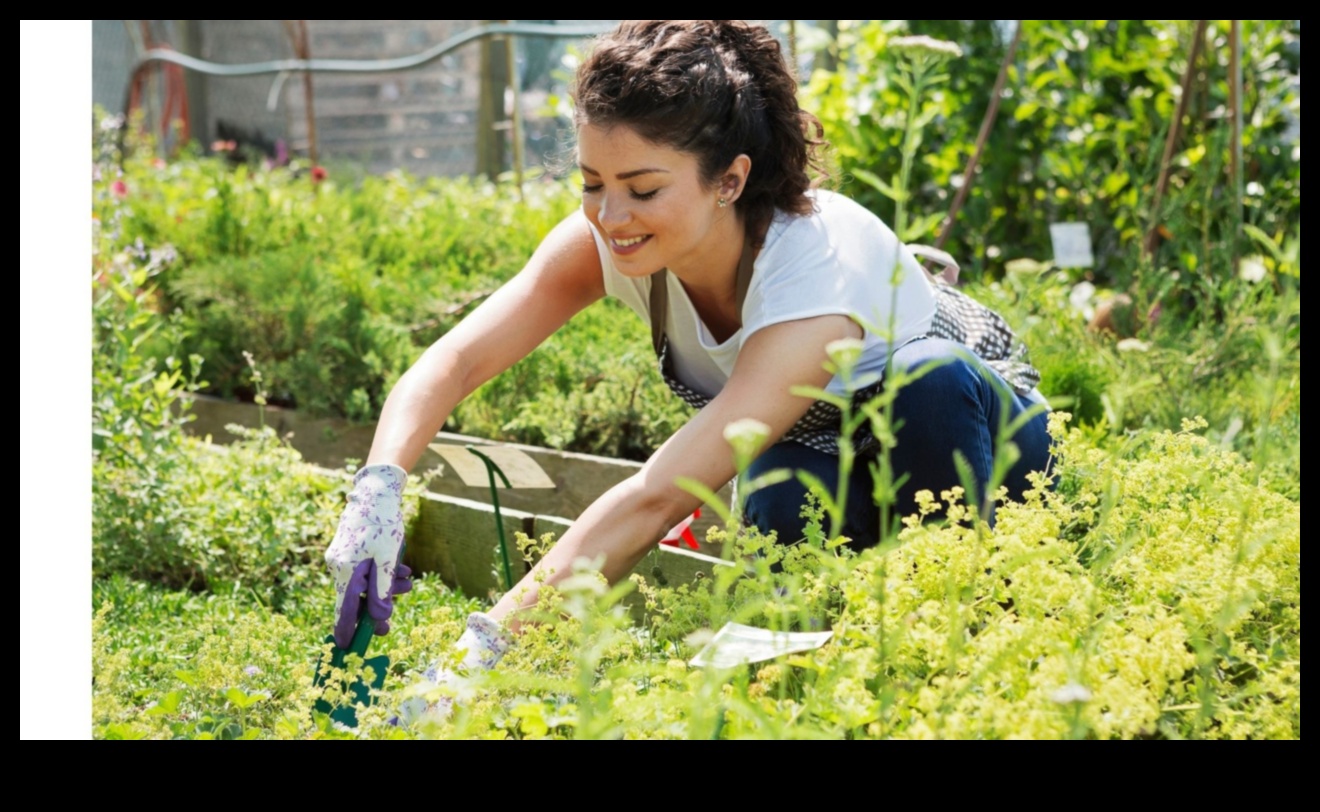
[803,20,1302,302]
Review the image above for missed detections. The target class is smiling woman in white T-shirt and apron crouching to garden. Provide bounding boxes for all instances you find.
[326,20,1049,717]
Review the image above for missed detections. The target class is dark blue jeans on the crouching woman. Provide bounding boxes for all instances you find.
[746,338,1049,548]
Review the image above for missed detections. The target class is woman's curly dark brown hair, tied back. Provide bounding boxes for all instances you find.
[573,20,826,244]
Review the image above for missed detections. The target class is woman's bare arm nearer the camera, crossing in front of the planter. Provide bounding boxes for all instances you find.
[490,316,862,628]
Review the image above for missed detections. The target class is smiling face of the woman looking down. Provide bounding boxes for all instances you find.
[578,124,742,277]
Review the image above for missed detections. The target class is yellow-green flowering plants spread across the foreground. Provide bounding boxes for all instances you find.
[94,420,1302,738]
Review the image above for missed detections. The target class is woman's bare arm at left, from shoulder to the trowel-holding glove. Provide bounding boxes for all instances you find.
[367,211,605,470]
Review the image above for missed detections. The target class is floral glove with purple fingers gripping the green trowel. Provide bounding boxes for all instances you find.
[326,465,412,648]
